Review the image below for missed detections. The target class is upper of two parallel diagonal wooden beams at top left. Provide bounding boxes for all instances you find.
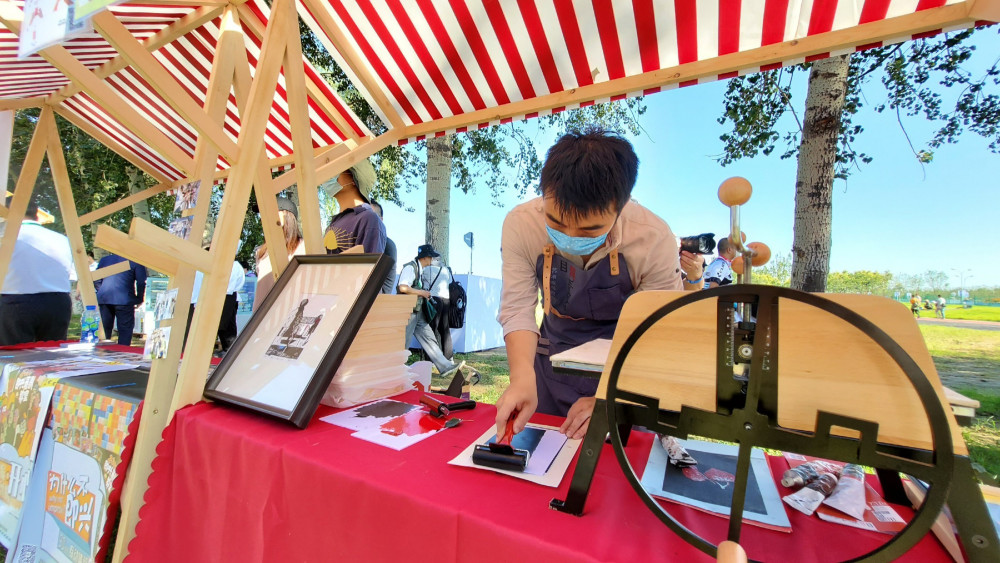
[90,10,238,162]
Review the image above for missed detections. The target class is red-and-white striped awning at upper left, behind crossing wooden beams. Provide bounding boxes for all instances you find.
[0,0,370,180]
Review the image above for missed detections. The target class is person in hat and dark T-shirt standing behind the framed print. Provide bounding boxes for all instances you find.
[323,160,385,254]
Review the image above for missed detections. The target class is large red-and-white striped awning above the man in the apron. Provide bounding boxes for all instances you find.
[300,0,995,142]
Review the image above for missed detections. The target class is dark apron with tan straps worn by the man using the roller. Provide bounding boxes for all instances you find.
[535,244,635,416]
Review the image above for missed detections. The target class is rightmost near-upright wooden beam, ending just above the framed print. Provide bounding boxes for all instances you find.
[284,10,326,254]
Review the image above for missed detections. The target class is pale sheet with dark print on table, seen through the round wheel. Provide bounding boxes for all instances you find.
[641,440,792,532]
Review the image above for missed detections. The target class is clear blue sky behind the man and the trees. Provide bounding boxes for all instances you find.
[385,32,1000,288]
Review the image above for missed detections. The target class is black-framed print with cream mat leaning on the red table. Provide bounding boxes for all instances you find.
[205,254,390,428]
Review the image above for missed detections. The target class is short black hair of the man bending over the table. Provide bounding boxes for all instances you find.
[542,128,639,219]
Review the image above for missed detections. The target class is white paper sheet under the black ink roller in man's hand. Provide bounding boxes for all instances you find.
[448,424,580,487]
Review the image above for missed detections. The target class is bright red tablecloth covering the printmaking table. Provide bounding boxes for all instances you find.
[129,393,948,563]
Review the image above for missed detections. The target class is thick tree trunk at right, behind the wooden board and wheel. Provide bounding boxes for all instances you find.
[792,55,850,292]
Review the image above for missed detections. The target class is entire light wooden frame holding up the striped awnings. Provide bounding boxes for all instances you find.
[0,0,1000,562]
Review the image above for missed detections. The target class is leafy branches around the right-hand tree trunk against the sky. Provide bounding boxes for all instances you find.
[718,28,1000,178]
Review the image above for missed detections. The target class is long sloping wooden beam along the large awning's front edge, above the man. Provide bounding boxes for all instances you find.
[400,0,1000,141]
